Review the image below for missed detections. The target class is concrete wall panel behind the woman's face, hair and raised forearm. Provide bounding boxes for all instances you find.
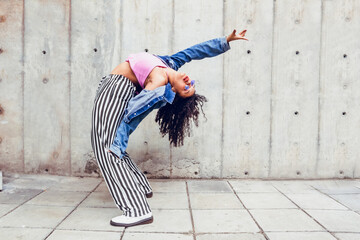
[172,0,223,177]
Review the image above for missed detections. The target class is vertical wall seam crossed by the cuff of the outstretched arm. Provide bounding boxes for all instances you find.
[220,0,226,178]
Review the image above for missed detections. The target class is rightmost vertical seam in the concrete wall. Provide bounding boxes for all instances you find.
[314,0,324,174]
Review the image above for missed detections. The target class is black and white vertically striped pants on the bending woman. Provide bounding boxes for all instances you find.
[91,74,152,217]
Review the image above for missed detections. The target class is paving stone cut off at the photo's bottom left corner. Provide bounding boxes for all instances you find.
[0,227,52,240]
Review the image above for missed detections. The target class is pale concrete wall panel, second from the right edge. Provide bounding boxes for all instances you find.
[269,0,321,178]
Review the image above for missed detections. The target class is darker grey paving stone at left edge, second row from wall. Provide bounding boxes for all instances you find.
[0,189,42,204]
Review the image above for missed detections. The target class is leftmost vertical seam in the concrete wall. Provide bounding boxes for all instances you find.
[21,0,25,172]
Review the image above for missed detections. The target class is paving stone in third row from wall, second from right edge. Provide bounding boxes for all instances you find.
[250,209,324,232]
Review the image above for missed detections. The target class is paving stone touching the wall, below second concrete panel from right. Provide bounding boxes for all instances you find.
[271,180,317,193]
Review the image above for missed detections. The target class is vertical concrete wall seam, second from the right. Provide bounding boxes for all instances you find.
[267,0,276,177]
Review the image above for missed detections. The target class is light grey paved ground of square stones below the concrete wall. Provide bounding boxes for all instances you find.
[0,175,360,240]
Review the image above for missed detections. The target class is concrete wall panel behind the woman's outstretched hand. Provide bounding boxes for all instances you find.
[222,0,273,178]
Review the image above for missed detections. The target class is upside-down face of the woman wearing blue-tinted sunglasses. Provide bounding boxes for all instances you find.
[168,71,195,98]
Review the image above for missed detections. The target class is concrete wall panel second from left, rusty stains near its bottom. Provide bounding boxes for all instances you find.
[24,0,70,175]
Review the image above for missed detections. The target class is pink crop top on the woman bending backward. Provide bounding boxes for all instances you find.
[126,52,167,88]
